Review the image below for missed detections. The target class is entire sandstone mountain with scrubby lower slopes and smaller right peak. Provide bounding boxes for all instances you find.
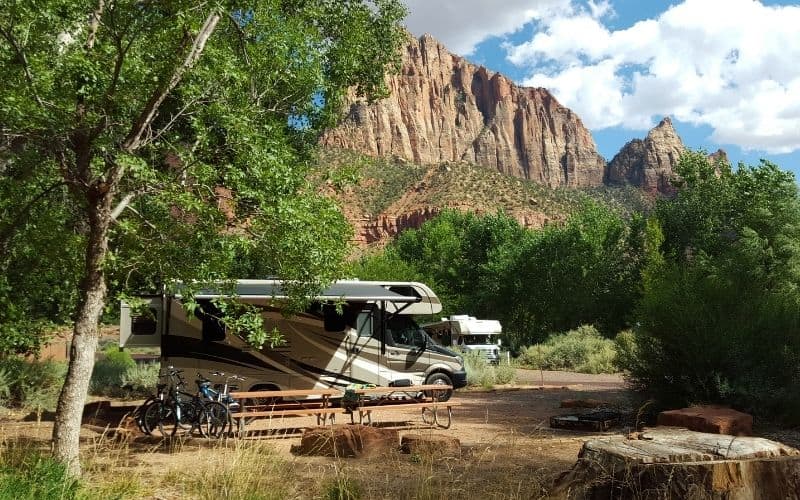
[320,35,704,245]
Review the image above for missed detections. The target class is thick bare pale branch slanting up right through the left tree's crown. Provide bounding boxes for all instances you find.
[122,12,220,153]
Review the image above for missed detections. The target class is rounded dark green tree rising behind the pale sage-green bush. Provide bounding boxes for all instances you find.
[495,202,644,344]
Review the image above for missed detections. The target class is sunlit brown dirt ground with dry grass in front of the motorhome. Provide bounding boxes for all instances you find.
[0,370,648,499]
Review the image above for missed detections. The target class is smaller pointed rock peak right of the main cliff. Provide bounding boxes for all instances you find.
[605,118,684,194]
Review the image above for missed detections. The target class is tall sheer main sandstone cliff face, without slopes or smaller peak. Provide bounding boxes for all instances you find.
[322,35,605,187]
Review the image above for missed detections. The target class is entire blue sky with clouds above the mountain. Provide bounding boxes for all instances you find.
[405,0,800,179]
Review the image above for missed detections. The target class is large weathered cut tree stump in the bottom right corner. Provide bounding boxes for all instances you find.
[552,427,800,500]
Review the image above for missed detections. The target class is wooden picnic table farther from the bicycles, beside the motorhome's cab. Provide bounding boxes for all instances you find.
[342,384,460,429]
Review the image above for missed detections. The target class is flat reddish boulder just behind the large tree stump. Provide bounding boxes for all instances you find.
[657,406,753,436]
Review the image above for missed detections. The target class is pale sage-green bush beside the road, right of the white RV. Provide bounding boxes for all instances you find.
[519,325,618,373]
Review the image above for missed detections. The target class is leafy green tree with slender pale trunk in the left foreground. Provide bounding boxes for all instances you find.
[0,0,404,474]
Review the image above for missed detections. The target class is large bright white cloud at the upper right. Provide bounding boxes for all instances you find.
[506,0,800,153]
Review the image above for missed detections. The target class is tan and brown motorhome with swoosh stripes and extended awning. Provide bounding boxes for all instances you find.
[120,280,466,397]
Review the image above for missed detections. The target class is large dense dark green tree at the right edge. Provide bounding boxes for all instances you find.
[628,153,800,418]
